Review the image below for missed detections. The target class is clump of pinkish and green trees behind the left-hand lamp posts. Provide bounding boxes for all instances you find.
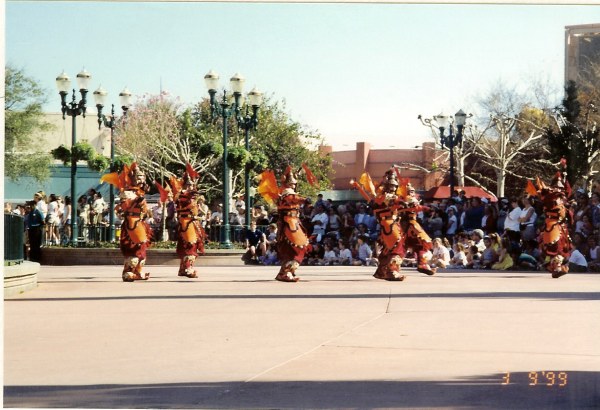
[116,95,331,207]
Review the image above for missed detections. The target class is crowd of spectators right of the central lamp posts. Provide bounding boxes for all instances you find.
[237,190,600,272]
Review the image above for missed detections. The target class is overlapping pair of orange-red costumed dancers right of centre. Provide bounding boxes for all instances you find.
[350,167,435,281]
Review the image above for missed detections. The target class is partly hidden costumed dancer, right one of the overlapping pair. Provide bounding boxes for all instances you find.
[394,179,436,276]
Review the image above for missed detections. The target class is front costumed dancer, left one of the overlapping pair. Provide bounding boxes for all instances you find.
[350,170,406,281]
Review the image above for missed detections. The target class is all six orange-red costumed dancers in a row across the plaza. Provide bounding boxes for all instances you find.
[101,160,573,282]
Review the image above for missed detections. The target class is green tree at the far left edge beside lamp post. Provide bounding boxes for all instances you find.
[4,65,52,181]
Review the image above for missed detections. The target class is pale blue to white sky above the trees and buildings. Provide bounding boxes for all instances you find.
[4,1,600,150]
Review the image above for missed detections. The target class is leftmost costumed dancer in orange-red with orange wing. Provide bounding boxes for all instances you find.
[100,162,152,282]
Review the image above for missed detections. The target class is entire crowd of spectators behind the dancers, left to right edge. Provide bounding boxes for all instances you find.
[10,189,600,272]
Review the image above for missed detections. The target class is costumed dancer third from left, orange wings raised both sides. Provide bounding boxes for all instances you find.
[258,165,316,282]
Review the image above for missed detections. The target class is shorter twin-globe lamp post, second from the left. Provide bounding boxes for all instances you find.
[94,86,131,242]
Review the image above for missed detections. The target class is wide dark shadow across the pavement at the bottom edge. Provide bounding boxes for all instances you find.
[4,370,600,409]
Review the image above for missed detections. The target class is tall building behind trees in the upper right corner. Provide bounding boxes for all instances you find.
[565,23,600,84]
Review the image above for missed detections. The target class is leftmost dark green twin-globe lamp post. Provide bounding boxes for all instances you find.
[56,69,92,246]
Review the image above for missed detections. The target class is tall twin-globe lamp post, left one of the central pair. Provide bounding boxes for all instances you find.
[204,70,245,249]
